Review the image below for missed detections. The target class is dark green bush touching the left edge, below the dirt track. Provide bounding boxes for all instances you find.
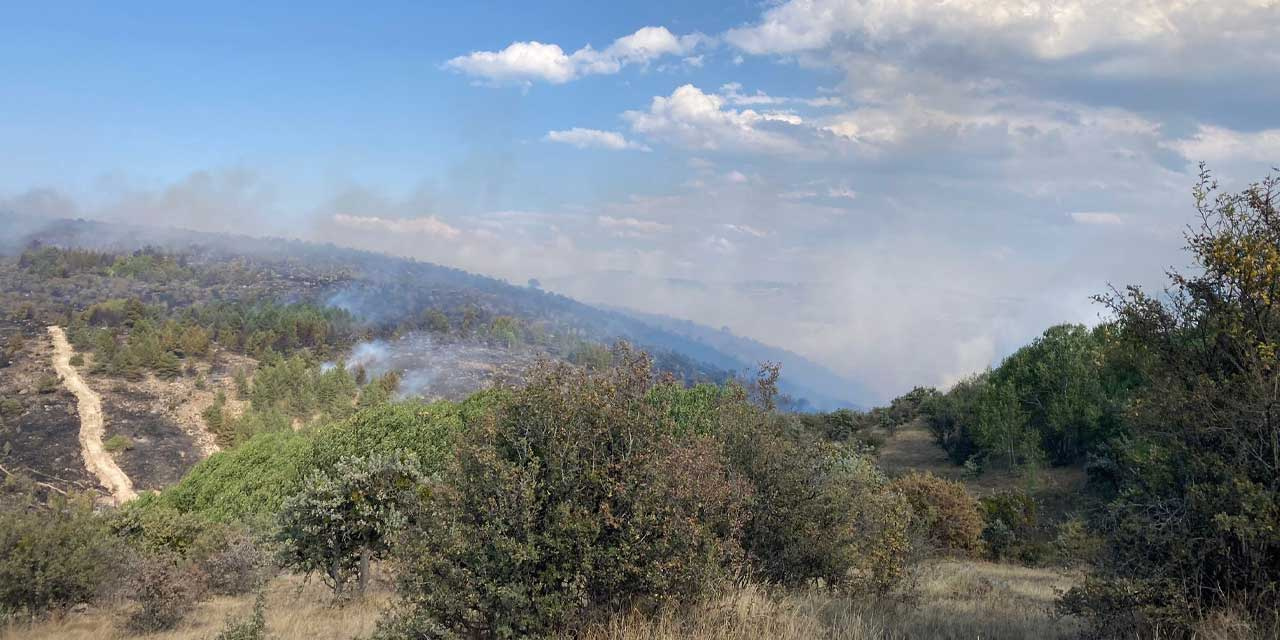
[0,499,120,616]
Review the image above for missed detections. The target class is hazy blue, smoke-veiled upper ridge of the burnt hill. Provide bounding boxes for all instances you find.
[0,212,867,410]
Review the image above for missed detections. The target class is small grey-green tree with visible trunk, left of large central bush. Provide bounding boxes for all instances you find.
[276,454,428,595]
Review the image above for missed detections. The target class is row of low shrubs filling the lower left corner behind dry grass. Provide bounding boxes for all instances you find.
[0,486,270,634]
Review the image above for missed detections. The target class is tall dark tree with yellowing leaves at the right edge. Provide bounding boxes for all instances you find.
[1069,172,1280,630]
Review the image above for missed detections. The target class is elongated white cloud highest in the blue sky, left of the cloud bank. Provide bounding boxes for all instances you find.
[444,27,707,86]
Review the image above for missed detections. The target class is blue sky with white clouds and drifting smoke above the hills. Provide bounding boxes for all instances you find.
[0,0,1280,401]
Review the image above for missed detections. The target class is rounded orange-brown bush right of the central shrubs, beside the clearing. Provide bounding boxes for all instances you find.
[892,472,983,554]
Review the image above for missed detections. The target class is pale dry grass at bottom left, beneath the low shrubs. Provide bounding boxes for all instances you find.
[0,576,390,640]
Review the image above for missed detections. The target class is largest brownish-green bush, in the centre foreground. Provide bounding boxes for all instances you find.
[379,352,748,637]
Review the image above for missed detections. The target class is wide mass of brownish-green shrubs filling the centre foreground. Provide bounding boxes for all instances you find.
[380,348,911,637]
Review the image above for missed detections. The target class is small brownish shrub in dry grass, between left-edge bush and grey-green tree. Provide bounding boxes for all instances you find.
[124,554,204,634]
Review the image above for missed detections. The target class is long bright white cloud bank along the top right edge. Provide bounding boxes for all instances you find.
[724,0,1280,65]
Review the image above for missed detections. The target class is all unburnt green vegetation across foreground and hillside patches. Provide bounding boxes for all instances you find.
[0,167,1280,640]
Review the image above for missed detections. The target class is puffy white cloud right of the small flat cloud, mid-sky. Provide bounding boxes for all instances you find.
[622,84,803,154]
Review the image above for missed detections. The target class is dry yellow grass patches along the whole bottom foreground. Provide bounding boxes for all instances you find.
[0,561,1079,640]
